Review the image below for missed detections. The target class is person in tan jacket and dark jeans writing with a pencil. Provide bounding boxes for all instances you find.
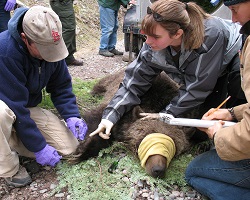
[186,0,250,200]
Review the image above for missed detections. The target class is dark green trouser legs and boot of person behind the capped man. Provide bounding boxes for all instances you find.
[50,0,83,66]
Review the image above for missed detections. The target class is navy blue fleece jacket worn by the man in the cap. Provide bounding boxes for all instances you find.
[0,8,80,152]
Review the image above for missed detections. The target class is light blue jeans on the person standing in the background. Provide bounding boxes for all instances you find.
[99,5,119,50]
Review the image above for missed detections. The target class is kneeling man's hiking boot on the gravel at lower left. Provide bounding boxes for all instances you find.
[4,165,32,187]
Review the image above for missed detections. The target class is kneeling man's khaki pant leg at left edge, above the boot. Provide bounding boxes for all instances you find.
[0,100,19,177]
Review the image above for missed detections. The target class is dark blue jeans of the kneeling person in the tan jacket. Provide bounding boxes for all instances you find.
[185,149,250,200]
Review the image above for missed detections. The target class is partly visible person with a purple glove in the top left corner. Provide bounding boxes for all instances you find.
[0,0,16,33]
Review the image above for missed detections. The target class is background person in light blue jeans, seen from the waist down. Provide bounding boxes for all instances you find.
[98,0,135,57]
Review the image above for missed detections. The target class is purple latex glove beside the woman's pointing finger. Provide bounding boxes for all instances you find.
[66,117,88,140]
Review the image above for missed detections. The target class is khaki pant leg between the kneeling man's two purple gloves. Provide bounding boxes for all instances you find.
[29,107,79,155]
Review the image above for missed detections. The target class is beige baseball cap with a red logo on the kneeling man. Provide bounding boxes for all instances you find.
[23,6,69,62]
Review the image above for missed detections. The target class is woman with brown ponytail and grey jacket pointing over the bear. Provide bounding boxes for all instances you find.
[91,0,242,144]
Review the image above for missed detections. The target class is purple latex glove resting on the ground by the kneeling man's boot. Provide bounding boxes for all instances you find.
[35,144,62,167]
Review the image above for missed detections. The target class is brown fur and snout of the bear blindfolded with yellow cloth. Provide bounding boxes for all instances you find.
[71,71,207,177]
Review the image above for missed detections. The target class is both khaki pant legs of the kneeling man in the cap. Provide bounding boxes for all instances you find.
[0,104,79,177]
